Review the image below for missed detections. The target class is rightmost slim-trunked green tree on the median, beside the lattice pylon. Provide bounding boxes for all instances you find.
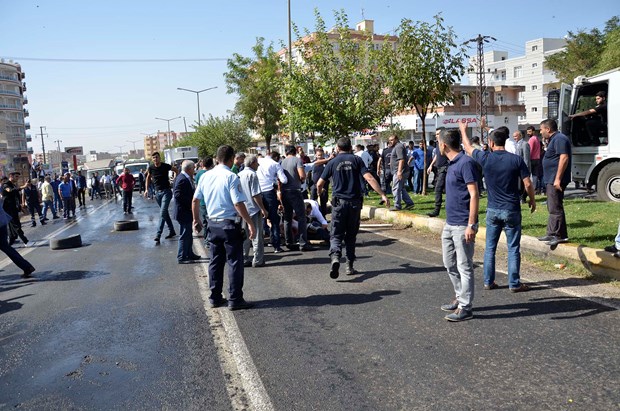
[383,15,466,194]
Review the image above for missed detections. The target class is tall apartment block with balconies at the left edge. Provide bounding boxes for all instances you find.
[0,59,32,175]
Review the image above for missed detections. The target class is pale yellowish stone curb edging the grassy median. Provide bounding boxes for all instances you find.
[362,206,620,280]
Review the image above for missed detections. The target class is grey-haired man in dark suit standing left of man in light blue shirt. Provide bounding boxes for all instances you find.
[172,160,202,264]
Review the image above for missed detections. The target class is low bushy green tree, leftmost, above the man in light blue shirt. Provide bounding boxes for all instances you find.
[175,114,252,157]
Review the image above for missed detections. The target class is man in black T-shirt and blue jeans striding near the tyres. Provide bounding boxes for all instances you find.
[144,152,178,244]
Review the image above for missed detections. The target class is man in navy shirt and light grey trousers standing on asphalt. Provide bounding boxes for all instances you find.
[438,130,478,321]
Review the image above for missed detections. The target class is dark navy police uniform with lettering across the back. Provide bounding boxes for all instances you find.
[321,153,370,264]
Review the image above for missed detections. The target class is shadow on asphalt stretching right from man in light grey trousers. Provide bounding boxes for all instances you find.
[475,296,616,320]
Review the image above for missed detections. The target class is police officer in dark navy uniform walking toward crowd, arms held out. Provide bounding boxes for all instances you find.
[317,137,390,278]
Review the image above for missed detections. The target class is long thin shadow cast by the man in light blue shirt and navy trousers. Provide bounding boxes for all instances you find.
[255,290,400,308]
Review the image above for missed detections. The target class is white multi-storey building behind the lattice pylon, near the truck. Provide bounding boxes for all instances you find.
[468,38,566,129]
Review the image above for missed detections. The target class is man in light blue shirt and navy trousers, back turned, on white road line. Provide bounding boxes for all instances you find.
[192,145,256,310]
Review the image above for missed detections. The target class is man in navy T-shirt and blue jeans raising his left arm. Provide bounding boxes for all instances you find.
[459,123,536,293]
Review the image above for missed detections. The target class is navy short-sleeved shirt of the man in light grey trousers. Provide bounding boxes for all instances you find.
[446,152,478,226]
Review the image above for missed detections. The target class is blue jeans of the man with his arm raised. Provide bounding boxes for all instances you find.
[484,208,521,288]
